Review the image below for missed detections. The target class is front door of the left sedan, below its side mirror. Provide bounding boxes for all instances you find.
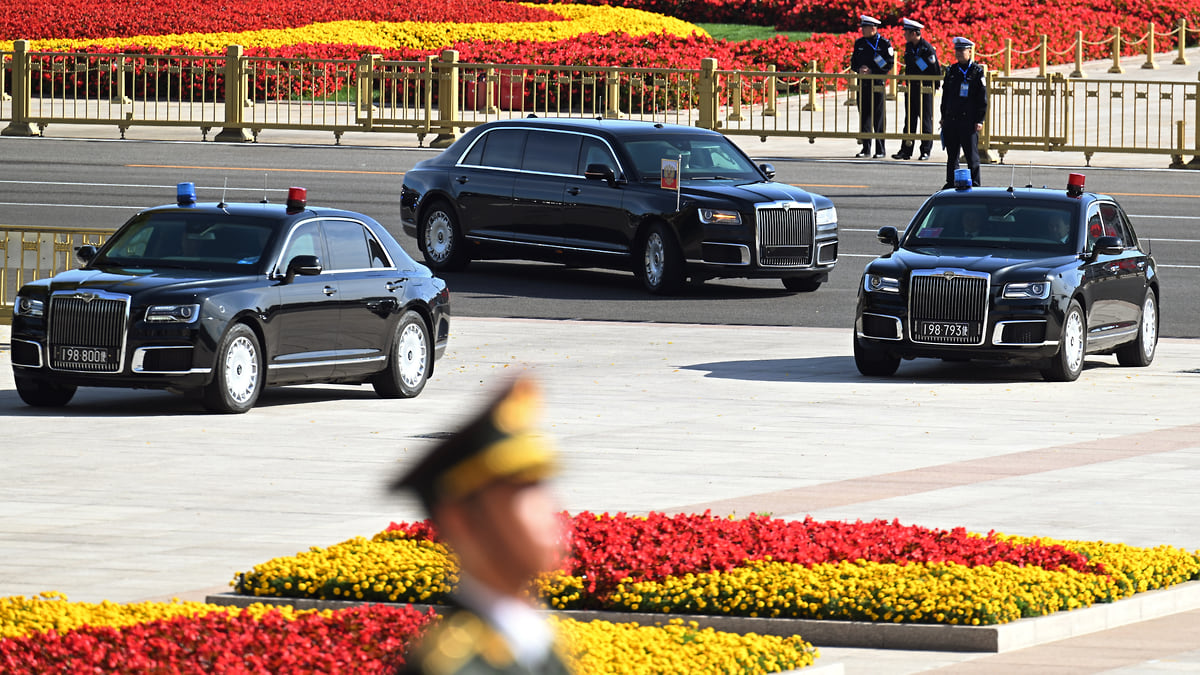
[266,220,341,382]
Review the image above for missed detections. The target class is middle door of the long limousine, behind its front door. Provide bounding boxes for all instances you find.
[512,130,581,247]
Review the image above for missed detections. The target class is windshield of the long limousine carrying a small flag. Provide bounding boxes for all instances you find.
[625,135,762,183]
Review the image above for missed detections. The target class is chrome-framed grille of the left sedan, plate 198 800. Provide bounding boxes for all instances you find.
[47,293,130,372]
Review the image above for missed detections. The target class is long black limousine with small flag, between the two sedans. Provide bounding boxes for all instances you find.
[401,118,838,293]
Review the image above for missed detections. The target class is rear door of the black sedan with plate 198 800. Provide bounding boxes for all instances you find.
[322,217,407,377]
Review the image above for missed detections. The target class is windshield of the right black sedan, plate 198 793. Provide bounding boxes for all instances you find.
[904,197,1079,255]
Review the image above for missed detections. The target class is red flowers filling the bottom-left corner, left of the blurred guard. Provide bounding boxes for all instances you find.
[0,605,433,675]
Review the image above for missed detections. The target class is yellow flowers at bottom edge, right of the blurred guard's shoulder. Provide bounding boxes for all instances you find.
[551,619,818,675]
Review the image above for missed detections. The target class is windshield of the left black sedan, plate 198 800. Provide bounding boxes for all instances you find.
[91,211,276,274]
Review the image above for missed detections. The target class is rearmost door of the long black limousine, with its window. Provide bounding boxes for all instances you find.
[450,129,528,239]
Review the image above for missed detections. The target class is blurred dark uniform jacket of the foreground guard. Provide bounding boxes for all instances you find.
[397,607,570,675]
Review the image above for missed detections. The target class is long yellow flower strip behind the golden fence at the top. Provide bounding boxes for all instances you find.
[18,5,708,52]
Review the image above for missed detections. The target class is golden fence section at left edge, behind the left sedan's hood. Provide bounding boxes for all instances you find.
[0,226,110,323]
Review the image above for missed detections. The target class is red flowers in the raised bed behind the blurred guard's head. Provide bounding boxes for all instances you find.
[388,512,1104,595]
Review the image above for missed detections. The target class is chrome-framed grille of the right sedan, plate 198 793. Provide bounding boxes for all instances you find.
[908,270,990,345]
